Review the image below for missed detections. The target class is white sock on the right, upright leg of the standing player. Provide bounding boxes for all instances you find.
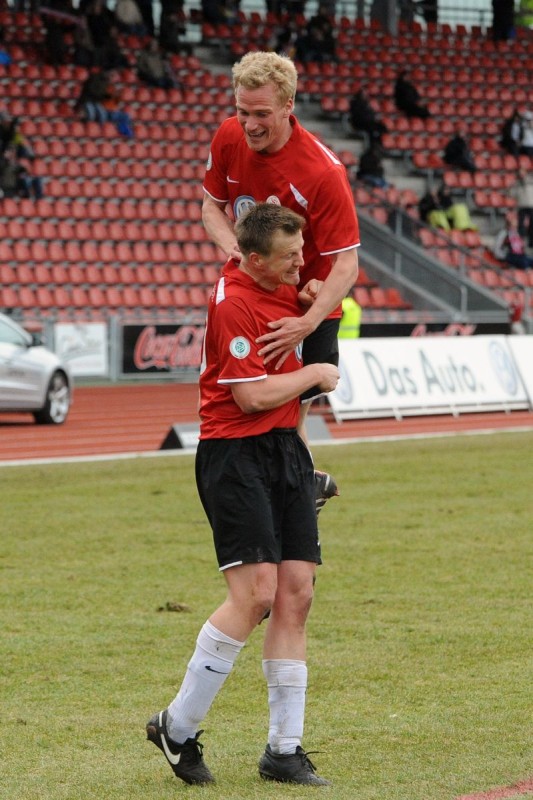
[263,658,307,754]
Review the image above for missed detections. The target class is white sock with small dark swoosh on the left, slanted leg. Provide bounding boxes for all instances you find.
[167,620,245,744]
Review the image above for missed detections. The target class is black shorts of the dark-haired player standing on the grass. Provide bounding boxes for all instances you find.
[196,428,320,570]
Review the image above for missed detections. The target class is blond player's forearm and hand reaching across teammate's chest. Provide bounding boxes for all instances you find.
[256,247,359,368]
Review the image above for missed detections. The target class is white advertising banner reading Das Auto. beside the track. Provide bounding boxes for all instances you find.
[328,336,529,420]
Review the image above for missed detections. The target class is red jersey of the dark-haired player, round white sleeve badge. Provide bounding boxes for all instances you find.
[200,262,302,439]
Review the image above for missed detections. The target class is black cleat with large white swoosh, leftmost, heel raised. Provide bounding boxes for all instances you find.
[146,710,215,784]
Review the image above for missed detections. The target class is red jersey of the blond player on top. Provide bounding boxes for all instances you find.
[204,116,360,317]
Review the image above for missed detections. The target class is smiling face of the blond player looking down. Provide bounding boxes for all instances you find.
[235,83,294,153]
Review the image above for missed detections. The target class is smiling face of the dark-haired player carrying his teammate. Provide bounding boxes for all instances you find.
[243,231,304,291]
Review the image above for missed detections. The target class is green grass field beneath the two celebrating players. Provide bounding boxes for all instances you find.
[0,433,533,800]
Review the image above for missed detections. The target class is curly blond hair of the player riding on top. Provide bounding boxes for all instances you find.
[232,51,298,105]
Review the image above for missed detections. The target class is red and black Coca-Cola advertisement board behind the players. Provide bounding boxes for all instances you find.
[122,324,204,374]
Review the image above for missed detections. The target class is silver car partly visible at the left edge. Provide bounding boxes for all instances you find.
[0,314,72,425]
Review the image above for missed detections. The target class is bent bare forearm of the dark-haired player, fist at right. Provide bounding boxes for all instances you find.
[231,364,339,414]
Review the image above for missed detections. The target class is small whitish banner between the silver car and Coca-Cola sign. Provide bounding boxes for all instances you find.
[54,322,109,377]
